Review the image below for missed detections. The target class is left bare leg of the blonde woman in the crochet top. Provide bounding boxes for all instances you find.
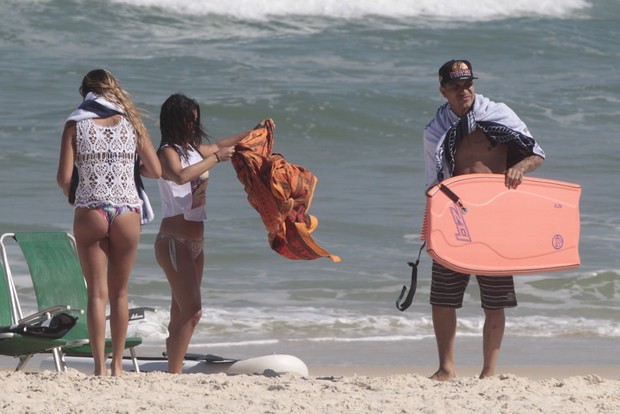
[73,208,108,375]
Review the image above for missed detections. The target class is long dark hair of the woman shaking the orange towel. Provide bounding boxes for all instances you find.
[159,93,209,156]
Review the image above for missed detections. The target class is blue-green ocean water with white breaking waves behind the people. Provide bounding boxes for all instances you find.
[0,0,620,365]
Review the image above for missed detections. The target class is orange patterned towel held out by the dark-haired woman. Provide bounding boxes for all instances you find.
[231,127,340,262]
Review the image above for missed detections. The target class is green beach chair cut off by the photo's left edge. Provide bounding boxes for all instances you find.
[0,244,67,371]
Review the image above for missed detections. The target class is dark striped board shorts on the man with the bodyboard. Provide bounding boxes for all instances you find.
[430,260,517,309]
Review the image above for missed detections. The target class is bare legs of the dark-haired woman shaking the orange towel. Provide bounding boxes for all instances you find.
[155,238,204,374]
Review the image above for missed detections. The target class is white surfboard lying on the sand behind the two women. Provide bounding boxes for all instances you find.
[39,354,308,377]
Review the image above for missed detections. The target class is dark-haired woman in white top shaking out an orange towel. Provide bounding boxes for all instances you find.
[155,94,273,373]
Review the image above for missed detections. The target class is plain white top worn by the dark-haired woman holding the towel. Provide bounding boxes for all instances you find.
[157,145,209,221]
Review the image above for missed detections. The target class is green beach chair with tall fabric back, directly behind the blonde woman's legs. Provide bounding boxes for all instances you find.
[0,232,144,372]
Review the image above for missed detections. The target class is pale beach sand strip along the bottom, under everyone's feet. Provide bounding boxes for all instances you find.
[0,366,620,414]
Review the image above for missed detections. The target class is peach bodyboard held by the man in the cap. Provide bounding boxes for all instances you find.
[422,174,581,275]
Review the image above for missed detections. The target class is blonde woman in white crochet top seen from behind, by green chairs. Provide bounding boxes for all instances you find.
[57,69,161,376]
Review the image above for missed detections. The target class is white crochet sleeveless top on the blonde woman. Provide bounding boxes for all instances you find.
[74,117,142,207]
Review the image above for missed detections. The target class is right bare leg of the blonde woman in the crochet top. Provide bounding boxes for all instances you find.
[108,211,140,375]
